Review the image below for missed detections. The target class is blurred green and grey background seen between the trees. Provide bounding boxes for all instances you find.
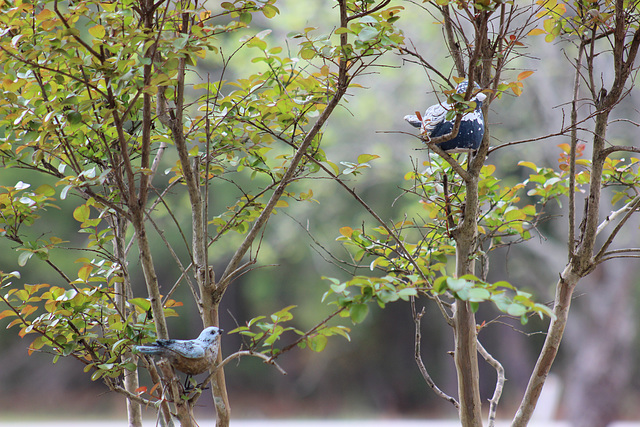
[0,0,640,419]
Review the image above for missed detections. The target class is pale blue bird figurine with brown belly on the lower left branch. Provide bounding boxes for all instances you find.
[135,326,222,375]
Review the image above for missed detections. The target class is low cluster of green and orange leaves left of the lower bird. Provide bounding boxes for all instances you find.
[0,266,180,380]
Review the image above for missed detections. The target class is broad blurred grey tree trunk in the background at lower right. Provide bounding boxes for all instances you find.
[564,259,638,427]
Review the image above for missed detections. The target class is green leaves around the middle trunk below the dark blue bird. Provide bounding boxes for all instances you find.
[316,150,566,323]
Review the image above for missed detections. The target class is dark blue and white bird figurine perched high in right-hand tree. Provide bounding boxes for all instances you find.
[404,80,487,153]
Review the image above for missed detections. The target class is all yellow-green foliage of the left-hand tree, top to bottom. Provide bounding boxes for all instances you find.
[0,0,412,388]
